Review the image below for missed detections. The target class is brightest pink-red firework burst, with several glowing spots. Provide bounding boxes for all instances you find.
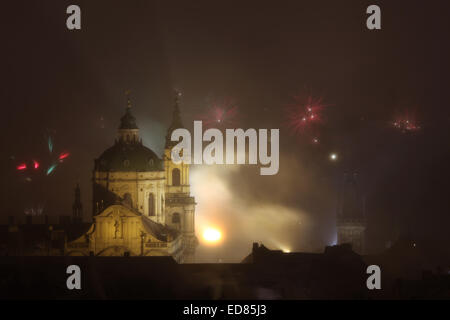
[286,95,326,138]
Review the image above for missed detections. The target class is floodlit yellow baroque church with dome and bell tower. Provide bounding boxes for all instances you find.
[64,94,198,263]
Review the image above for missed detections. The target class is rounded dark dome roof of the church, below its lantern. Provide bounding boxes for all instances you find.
[95,142,164,172]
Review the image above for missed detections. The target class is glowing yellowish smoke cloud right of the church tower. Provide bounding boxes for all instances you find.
[191,151,330,262]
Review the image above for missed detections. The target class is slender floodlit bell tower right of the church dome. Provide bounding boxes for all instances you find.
[164,92,197,262]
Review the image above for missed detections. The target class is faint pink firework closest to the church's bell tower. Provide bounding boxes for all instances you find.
[198,101,238,128]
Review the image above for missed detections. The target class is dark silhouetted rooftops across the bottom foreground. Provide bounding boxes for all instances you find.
[0,244,450,299]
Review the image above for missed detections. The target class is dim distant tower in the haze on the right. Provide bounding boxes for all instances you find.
[337,173,366,254]
